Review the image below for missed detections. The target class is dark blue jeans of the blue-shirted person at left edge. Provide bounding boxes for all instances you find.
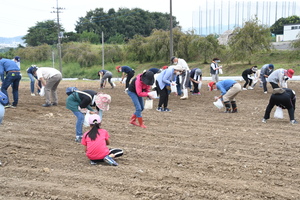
[1,72,22,106]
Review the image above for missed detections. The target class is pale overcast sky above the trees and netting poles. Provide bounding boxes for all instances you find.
[0,0,300,37]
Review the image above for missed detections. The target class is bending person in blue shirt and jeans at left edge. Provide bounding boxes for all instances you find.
[0,58,22,108]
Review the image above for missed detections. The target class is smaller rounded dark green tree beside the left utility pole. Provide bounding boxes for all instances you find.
[22,20,64,46]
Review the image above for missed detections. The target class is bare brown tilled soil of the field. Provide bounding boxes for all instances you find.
[0,81,300,200]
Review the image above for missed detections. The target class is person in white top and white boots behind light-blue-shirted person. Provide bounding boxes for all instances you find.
[171,56,191,100]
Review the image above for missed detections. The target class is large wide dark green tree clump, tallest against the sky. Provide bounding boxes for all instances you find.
[75,8,178,42]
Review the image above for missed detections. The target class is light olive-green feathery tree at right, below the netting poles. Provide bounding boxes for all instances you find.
[228,18,271,64]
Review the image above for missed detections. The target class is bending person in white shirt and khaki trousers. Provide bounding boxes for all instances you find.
[32,67,62,107]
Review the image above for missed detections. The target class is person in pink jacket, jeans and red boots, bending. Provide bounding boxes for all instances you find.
[127,70,154,128]
